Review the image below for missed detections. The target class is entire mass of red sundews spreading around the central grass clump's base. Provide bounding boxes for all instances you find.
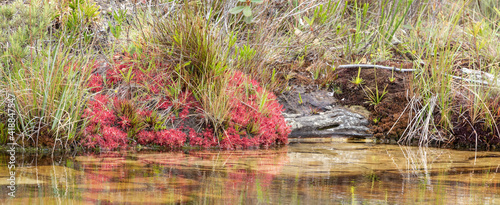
[81,54,290,149]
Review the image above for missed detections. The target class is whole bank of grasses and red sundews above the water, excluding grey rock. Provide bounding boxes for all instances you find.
[0,0,500,149]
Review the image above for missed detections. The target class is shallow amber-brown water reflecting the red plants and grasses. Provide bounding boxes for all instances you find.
[0,143,500,204]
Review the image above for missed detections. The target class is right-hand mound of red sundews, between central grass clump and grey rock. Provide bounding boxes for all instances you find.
[221,71,290,148]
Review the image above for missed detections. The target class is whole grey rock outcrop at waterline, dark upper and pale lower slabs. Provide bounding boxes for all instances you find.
[278,86,372,138]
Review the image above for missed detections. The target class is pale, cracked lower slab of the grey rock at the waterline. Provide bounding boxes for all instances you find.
[284,108,372,138]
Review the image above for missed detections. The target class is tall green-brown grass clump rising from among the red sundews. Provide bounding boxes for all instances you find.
[140,3,234,135]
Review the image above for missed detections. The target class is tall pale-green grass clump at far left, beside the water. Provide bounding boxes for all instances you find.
[1,40,91,147]
